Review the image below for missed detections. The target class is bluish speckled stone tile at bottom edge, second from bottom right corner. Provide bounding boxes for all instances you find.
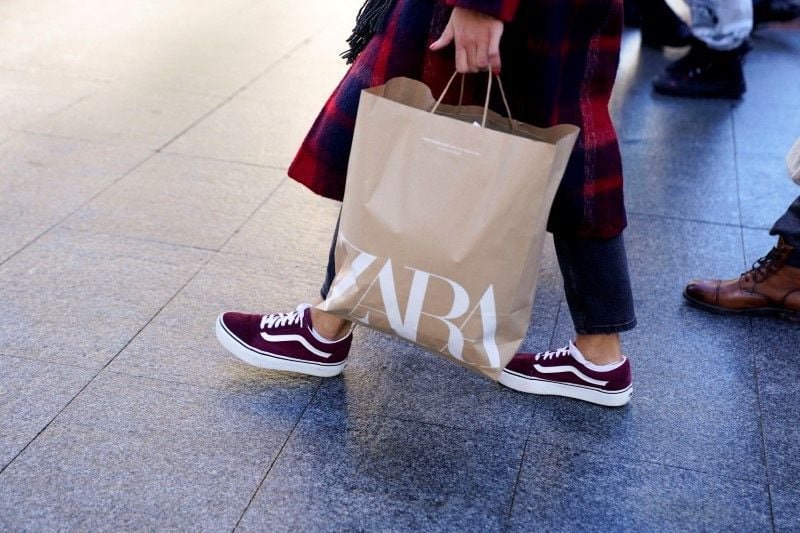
[509,443,772,531]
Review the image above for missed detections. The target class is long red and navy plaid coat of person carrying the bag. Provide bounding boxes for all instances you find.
[289,0,626,238]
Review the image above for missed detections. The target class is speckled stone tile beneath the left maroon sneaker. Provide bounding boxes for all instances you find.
[109,254,324,394]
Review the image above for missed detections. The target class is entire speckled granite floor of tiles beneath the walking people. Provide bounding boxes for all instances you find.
[0,0,800,531]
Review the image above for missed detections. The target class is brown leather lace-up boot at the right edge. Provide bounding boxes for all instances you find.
[683,239,800,320]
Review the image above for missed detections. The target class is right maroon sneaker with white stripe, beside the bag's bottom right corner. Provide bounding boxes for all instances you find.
[498,341,633,407]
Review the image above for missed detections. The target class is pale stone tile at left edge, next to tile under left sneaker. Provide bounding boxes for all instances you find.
[0,230,209,368]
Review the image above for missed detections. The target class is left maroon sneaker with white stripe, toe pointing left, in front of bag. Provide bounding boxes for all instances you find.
[216,304,353,378]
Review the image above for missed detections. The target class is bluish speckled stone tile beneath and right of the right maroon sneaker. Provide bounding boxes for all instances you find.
[530,295,766,483]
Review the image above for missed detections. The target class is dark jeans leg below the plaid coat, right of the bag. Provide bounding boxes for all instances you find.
[554,235,636,335]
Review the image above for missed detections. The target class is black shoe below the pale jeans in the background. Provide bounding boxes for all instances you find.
[653,41,750,99]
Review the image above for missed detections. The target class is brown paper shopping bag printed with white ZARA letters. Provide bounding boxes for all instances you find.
[318,75,578,379]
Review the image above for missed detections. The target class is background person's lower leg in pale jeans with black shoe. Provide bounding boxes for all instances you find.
[653,0,753,99]
